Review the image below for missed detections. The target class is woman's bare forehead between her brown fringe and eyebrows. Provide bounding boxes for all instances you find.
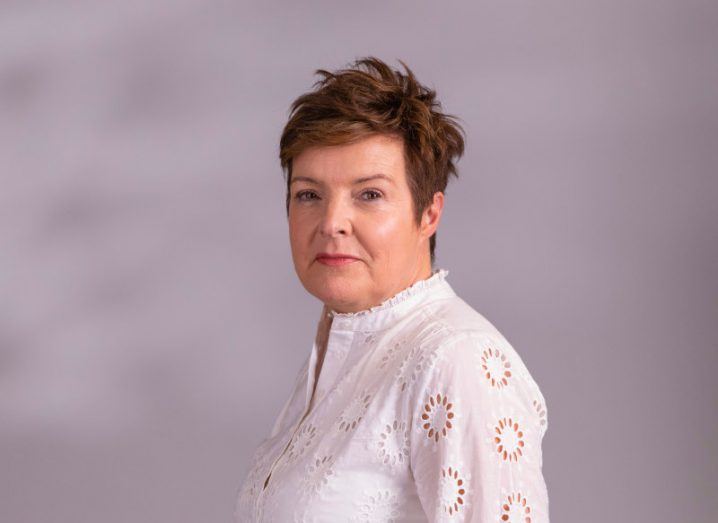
[292,135,404,182]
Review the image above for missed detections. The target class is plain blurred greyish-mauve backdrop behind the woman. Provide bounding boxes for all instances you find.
[0,0,718,523]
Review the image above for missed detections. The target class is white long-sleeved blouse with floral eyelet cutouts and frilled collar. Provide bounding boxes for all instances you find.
[235,269,549,523]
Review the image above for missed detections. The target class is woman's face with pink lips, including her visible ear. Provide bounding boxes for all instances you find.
[289,135,444,312]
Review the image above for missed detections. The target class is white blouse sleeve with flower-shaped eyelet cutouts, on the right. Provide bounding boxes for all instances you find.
[410,332,549,523]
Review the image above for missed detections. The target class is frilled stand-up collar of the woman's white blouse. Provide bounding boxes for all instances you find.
[327,268,456,331]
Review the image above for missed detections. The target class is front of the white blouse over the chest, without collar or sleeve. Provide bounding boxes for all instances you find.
[240,334,442,522]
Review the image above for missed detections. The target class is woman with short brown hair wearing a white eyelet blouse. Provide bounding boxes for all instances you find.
[235,57,548,523]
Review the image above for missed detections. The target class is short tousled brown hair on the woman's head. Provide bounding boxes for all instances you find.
[279,56,465,267]
